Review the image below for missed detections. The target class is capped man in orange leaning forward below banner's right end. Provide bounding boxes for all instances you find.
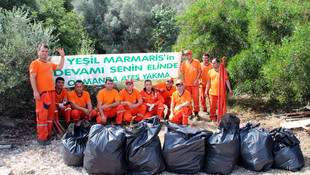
[153,77,176,119]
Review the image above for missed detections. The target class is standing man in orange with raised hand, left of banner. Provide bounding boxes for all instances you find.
[29,44,65,146]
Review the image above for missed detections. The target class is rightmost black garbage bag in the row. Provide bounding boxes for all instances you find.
[270,128,305,172]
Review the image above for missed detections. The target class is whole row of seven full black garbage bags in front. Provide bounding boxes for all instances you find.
[62,114,305,175]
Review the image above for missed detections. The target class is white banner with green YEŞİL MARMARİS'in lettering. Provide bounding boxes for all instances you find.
[50,52,182,88]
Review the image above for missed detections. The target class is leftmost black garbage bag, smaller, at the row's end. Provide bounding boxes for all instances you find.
[62,120,90,166]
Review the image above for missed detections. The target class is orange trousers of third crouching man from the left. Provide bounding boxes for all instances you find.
[97,105,124,125]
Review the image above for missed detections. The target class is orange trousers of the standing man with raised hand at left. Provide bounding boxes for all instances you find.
[36,90,55,140]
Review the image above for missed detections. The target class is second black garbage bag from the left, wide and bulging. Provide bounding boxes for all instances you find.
[84,124,127,174]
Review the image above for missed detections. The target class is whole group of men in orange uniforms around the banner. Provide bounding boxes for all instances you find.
[29,44,232,145]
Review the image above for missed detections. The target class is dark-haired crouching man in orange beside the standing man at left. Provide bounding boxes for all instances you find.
[55,77,72,125]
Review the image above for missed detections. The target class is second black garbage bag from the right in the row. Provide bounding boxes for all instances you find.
[239,123,273,171]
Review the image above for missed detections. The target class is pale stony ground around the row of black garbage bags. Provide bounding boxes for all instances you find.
[0,111,310,175]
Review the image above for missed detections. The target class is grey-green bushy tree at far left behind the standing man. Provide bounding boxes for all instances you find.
[0,8,55,116]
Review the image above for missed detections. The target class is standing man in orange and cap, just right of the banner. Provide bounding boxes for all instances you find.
[181,50,201,120]
